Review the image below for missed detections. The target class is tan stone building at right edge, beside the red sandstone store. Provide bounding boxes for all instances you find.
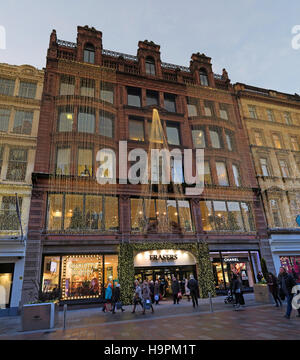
[235,83,300,282]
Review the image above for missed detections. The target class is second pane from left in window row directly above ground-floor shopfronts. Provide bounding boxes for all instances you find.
[64,195,85,230]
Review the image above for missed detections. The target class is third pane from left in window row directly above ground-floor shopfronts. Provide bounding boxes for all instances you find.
[85,196,103,230]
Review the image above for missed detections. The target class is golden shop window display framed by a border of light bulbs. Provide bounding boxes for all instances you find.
[62,255,103,300]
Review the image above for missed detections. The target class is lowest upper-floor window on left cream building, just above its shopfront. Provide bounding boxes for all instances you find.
[0,196,22,230]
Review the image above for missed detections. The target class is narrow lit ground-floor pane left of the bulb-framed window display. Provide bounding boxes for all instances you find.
[42,256,60,292]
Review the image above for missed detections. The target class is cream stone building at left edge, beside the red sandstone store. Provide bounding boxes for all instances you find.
[0,64,44,316]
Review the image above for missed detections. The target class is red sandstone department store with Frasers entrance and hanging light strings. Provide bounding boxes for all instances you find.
[23,26,272,302]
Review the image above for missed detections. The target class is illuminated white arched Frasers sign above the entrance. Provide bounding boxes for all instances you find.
[134,250,196,267]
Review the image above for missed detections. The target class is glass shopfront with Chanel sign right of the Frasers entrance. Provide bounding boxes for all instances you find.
[210,251,260,294]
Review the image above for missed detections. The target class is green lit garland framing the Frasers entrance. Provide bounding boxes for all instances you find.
[118,243,216,305]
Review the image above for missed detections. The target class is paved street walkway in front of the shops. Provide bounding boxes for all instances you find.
[0,294,300,340]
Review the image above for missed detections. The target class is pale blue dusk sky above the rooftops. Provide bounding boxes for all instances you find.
[0,0,300,94]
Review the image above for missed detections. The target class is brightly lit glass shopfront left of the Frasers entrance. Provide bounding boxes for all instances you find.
[42,254,118,300]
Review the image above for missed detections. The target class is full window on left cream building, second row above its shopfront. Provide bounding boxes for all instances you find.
[6,148,27,181]
